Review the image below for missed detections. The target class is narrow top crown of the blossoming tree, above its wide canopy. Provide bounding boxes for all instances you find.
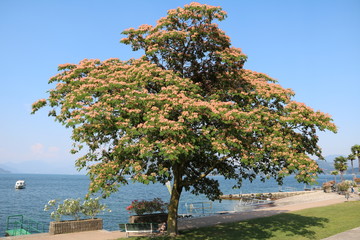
[121,3,246,93]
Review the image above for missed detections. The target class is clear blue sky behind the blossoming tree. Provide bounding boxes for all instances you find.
[0,0,360,173]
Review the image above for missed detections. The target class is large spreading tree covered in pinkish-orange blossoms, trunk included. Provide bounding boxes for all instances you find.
[33,3,336,234]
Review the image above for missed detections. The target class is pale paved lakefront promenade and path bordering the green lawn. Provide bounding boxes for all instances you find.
[0,191,360,240]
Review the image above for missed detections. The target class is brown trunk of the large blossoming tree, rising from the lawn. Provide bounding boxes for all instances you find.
[167,164,182,236]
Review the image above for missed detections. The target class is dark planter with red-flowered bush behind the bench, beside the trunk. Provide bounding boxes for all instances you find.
[126,198,168,223]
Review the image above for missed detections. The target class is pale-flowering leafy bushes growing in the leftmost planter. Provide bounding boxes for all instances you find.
[44,198,106,221]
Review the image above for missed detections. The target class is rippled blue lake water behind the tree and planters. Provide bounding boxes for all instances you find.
[0,174,352,236]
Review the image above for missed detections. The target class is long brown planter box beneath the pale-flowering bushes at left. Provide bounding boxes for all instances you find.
[49,218,103,234]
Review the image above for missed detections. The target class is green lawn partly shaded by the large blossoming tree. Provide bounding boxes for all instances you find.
[119,202,360,240]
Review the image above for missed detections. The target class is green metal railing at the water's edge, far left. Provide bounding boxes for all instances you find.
[5,215,47,236]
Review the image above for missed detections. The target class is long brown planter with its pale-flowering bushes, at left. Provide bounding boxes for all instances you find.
[44,198,106,234]
